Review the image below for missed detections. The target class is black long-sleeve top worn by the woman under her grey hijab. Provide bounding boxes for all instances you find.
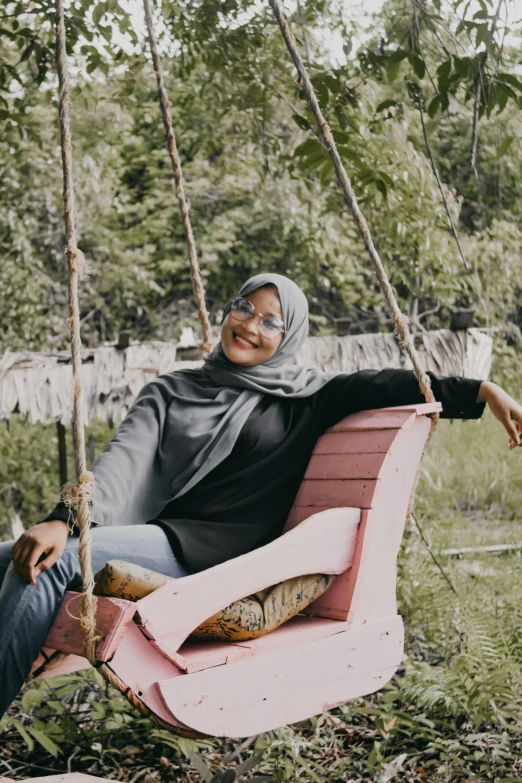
[42,370,485,573]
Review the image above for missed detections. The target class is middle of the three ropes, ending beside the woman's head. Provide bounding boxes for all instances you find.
[143,0,212,354]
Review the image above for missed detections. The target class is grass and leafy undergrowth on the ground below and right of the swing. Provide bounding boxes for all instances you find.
[0,402,522,783]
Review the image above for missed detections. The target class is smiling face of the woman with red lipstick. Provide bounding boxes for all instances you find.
[221,286,283,367]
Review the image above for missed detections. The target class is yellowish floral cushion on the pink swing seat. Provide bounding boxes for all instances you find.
[94,560,335,642]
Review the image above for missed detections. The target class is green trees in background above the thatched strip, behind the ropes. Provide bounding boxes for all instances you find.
[0,0,522,349]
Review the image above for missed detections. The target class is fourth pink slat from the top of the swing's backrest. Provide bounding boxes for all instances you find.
[294,479,378,508]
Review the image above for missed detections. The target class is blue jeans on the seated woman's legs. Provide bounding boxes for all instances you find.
[0,525,187,718]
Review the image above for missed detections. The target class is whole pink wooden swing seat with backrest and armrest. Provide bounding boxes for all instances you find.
[33,403,441,738]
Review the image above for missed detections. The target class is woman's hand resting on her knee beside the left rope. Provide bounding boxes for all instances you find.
[11,519,69,585]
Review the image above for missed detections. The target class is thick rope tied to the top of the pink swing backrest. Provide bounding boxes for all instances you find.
[268,0,438,414]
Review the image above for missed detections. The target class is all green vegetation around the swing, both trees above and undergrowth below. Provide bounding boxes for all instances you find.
[0,0,522,783]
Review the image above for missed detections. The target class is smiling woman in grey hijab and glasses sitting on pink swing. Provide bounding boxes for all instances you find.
[0,274,522,716]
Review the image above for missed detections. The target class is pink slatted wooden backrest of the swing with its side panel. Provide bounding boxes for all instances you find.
[284,403,441,624]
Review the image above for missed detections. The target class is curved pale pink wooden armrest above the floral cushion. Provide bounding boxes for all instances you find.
[136,508,361,652]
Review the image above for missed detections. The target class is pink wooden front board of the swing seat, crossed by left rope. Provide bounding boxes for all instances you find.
[45,591,136,661]
